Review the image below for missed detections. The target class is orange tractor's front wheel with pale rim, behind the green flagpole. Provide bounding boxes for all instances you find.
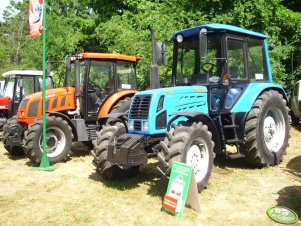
[24,116,73,165]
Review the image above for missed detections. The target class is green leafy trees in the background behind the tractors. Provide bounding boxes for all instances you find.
[0,0,301,89]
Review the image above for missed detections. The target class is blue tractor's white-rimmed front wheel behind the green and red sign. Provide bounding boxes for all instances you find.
[158,122,215,192]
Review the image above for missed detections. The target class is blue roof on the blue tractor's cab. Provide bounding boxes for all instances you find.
[171,24,268,41]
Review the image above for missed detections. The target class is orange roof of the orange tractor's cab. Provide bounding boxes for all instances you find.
[79,53,140,62]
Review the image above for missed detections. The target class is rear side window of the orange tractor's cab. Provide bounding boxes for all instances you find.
[116,61,136,89]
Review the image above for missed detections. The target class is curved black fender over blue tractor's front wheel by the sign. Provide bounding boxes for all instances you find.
[167,111,222,154]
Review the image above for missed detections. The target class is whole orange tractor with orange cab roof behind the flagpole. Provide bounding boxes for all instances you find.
[3,53,140,164]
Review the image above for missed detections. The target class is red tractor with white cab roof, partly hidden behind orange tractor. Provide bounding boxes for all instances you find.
[0,70,53,130]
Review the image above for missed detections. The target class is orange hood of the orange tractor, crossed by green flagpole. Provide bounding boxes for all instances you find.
[17,87,76,125]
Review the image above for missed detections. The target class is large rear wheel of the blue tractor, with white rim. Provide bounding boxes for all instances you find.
[242,90,290,166]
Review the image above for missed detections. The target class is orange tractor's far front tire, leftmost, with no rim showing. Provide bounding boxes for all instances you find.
[3,116,25,156]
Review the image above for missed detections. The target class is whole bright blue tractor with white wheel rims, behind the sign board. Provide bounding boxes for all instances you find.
[92,24,290,191]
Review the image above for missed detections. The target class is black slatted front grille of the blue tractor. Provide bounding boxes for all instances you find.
[130,95,151,119]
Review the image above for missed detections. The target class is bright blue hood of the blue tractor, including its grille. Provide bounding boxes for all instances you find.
[128,86,208,135]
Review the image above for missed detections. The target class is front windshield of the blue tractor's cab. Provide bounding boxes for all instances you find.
[174,33,223,85]
